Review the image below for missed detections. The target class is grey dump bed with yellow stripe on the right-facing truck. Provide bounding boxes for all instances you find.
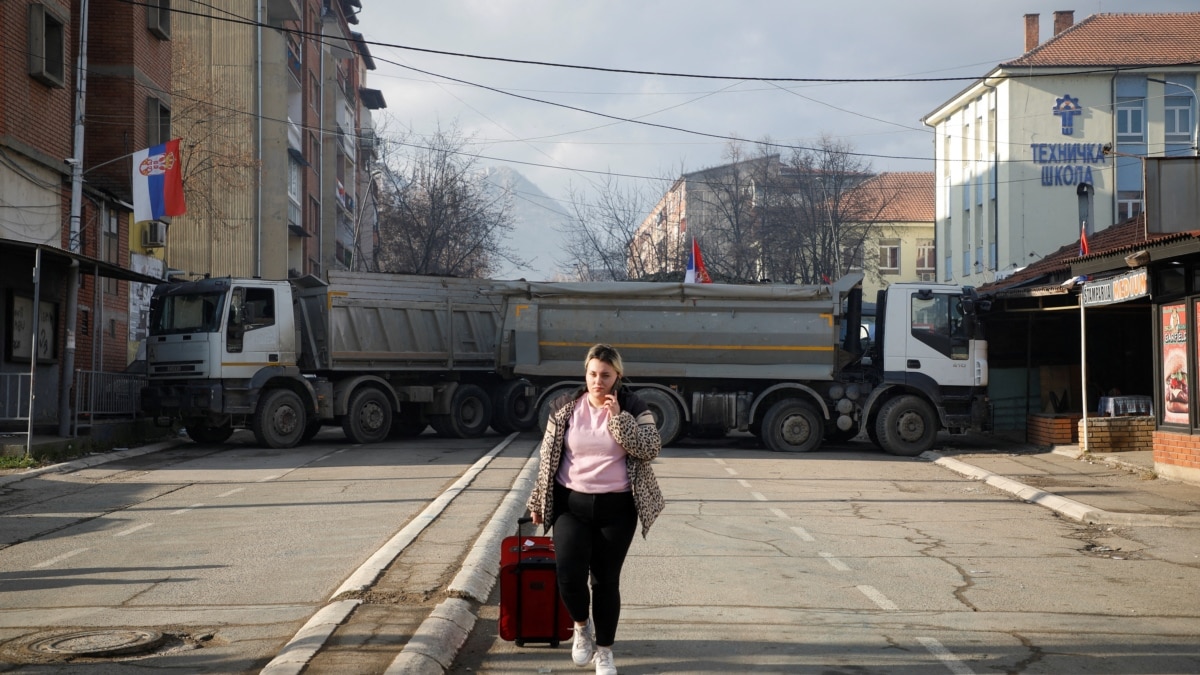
[498,275,862,381]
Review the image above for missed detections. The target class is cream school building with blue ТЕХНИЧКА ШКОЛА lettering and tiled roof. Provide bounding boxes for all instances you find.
[923,12,1200,285]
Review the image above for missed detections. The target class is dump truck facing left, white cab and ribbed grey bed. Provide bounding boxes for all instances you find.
[142,271,536,448]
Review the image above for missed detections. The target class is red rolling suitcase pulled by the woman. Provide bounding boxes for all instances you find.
[500,518,575,647]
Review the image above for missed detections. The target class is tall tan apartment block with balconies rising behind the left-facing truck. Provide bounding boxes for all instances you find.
[166,0,384,279]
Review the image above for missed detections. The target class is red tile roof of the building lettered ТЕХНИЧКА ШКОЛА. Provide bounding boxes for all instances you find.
[1001,12,1200,67]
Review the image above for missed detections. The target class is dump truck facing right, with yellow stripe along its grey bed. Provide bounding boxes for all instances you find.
[496,273,991,456]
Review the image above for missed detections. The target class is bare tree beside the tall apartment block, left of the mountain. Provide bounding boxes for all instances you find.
[377,125,516,277]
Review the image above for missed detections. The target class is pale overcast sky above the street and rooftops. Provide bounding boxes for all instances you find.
[355,0,1200,273]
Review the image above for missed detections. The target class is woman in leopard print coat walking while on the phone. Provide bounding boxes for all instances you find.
[528,345,664,675]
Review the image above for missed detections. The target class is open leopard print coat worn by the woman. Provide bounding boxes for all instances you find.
[526,388,664,538]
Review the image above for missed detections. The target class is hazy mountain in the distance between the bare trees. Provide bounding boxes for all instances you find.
[487,167,569,281]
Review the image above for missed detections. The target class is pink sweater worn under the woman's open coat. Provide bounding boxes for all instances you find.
[558,394,629,495]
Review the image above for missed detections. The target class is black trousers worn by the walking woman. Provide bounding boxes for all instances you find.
[552,483,637,647]
